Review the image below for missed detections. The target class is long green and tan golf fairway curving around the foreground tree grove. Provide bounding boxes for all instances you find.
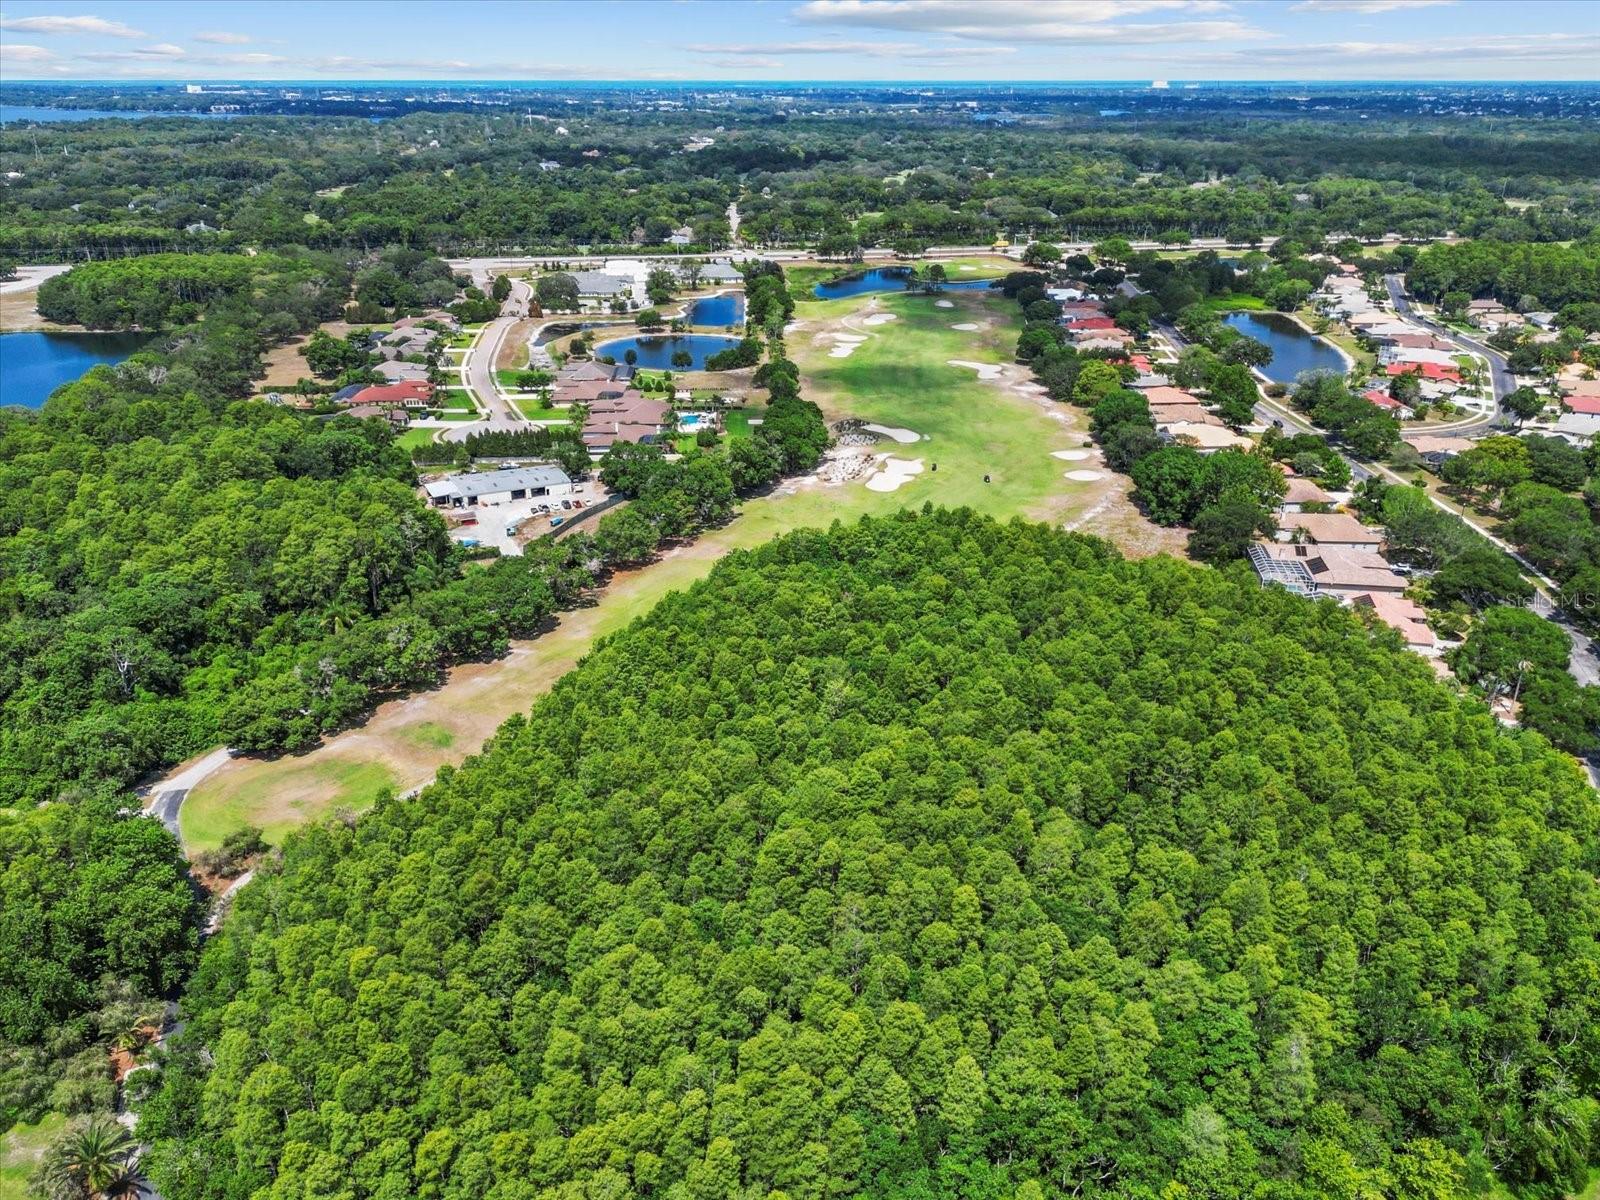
[179,291,1112,853]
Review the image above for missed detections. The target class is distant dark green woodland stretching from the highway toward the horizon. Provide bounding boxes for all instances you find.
[0,96,1600,261]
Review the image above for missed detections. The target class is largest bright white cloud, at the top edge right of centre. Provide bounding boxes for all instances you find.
[794,0,1267,45]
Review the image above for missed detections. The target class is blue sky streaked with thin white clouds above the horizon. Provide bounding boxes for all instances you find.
[0,0,1600,82]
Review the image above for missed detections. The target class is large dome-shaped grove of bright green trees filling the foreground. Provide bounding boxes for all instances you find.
[141,510,1600,1200]
